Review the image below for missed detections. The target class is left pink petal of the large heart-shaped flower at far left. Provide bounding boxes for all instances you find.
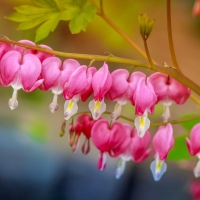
[0,51,21,85]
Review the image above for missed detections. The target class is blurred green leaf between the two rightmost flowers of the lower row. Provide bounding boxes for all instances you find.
[167,134,192,161]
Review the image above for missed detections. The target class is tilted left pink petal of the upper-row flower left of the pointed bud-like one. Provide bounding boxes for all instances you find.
[63,65,87,100]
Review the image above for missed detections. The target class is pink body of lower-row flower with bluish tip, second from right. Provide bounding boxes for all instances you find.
[153,124,174,160]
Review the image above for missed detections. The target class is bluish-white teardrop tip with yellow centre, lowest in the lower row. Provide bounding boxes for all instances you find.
[150,159,167,181]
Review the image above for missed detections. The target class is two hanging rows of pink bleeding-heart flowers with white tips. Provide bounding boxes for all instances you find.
[0,40,194,181]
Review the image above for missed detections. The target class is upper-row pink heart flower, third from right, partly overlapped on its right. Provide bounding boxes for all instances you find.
[106,69,145,121]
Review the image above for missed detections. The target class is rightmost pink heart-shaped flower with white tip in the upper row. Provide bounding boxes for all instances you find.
[149,72,191,122]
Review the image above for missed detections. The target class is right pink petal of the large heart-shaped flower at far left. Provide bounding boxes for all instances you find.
[20,54,42,91]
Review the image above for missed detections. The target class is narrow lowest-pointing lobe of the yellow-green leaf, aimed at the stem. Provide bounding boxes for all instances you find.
[35,14,61,42]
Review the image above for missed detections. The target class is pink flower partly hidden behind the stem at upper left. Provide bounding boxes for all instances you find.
[14,40,54,63]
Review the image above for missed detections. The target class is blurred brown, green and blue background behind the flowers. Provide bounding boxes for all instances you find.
[0,0,200,200]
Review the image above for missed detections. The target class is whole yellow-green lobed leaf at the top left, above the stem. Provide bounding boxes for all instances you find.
[7,0,97,42]
